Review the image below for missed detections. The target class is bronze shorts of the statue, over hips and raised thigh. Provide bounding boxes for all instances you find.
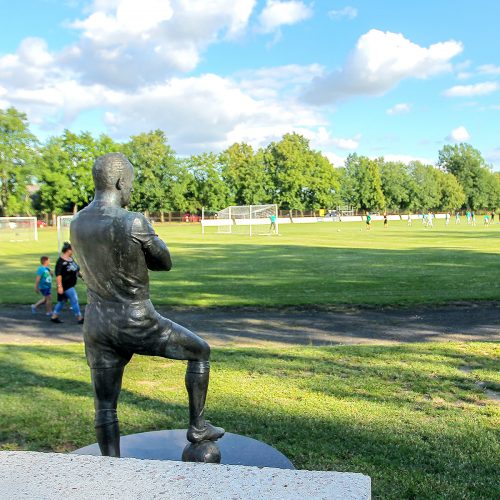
[83,300,210,368]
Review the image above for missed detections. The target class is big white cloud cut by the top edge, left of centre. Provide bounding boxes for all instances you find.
[65,0,256,88]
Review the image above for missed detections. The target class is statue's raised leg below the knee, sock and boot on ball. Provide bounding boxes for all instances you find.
[186,361,225,443]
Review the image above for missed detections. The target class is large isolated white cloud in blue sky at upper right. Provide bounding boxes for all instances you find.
[304,29,462,104]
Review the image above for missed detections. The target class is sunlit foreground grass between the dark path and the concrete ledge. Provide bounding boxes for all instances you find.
[0,343,500,499]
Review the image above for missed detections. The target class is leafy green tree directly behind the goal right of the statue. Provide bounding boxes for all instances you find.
[220,142,271,205]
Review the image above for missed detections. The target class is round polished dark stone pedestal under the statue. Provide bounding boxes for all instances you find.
[73,429,295,469]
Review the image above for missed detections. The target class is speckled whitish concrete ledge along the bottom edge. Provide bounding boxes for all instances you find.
[0,451,371,500]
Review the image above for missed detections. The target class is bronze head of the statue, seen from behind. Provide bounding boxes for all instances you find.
[92,153,134,207]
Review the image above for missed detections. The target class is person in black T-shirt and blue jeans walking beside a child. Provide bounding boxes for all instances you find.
[50,241,83,324]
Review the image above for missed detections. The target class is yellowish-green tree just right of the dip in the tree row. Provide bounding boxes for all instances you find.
[344,154,385,210]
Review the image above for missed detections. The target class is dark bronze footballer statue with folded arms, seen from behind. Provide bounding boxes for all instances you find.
[70,153,224,456]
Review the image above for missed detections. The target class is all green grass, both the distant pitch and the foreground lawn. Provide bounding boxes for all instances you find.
[0,222,500,499]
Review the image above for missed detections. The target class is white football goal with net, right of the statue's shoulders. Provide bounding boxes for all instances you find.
[201,205,278,236]
